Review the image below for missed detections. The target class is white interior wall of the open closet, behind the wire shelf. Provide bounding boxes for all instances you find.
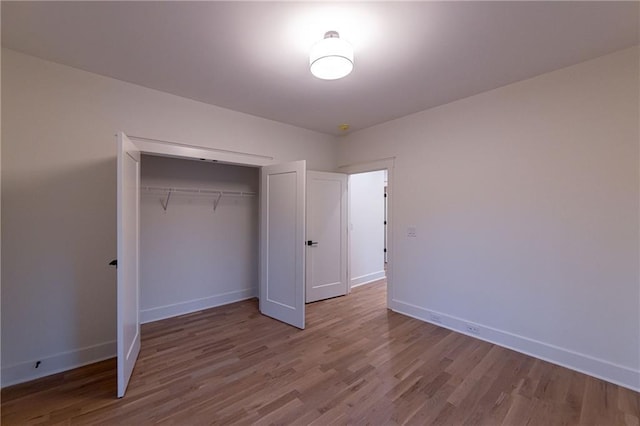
[140,155,259,322]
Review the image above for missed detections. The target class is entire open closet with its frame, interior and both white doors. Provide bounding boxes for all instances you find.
[116,132,306,398]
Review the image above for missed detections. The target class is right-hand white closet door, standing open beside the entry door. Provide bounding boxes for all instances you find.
[260,161,306,329]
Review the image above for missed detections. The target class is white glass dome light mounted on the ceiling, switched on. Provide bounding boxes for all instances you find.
[309,31,353,80]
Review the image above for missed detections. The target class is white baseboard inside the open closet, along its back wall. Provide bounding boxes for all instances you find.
[140,287,258,324]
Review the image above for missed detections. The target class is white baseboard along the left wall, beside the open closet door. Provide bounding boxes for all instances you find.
[1,340,116,388]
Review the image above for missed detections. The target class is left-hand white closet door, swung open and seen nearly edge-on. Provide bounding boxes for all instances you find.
[117,132,140,398]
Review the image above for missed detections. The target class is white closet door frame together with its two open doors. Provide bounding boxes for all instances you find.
[116,132,306,397]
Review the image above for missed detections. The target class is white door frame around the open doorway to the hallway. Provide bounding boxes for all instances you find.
[337,157,395,309]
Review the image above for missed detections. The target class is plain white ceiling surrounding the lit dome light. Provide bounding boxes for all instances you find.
[2,1,640,135]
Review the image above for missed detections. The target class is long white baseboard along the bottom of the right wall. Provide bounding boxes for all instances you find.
[390,299,640,392]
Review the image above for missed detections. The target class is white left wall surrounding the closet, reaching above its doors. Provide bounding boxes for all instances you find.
[1,49,336,385]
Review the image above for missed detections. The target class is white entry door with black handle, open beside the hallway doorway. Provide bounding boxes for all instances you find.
[306,171,347,302]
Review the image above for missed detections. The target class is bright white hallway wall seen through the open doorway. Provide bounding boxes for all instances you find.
[349,170,386,287]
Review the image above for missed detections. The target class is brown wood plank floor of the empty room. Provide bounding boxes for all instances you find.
[2,282,640,426]
